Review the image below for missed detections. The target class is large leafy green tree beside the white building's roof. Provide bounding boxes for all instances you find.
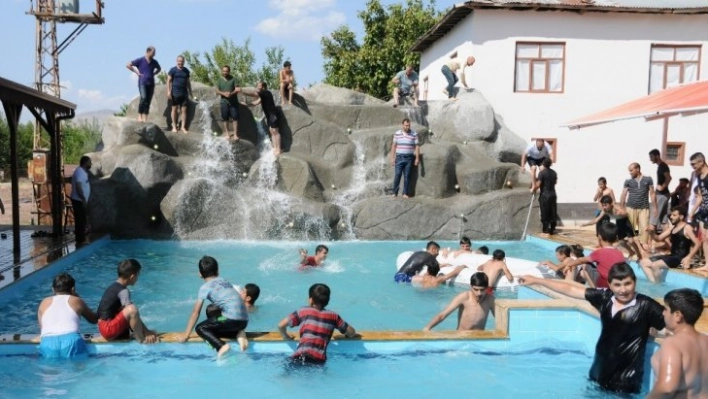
[321,0,443,98]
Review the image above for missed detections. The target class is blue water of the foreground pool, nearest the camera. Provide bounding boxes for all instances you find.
[0,342,640,399]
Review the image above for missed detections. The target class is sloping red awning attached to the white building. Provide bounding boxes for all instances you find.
[561,81,708,129]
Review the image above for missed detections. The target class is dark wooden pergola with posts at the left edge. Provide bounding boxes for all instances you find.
[0,77,76,262]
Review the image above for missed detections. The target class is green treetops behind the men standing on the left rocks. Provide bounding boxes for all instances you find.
[184,38,286,88]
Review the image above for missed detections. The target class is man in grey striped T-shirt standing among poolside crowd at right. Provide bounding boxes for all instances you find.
[620,162,658,244]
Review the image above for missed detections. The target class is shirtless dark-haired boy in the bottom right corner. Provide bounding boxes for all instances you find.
[647,288,708,399]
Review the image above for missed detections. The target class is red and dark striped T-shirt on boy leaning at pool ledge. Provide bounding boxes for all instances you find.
[288,307,349,361]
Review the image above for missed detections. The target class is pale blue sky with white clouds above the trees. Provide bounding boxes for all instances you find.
[0,0,459,113]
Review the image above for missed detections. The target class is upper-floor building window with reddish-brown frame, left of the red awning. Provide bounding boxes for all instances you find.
[514,42,565,93]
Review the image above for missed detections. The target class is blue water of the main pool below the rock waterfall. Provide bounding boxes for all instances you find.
[0,240,696,334]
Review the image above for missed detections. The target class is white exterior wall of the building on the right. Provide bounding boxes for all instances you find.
[420,10,708,203]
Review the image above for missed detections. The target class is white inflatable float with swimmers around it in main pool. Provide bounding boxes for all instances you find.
[396,251,552,287]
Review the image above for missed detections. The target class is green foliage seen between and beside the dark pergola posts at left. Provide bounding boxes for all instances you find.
[0,114,102,169]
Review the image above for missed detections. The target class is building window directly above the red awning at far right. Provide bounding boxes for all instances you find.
[649,44,701,93]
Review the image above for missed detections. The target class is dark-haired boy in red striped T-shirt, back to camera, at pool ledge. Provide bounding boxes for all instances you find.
[278,284,356,364]
